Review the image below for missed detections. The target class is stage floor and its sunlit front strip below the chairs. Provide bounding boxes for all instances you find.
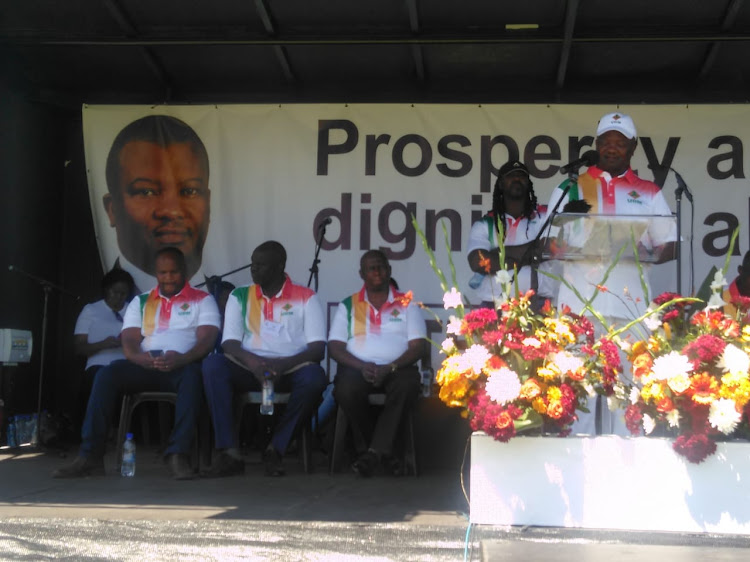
[0,444,750,562]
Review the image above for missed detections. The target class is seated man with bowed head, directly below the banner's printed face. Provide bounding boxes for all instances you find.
[53,248,219,480]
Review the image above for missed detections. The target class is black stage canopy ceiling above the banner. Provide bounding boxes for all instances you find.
[0,0,750,106]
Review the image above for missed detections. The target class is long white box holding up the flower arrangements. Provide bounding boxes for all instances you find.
[470,432,750,534]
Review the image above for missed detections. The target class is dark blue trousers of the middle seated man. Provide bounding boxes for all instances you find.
[203,354,326,455]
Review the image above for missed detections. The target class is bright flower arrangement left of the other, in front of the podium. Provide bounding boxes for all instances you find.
[413,214,622,442]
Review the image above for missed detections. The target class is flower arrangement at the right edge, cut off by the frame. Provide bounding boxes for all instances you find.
[625,230,750,463]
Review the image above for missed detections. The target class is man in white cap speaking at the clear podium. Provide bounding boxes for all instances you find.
[548,112,677,435]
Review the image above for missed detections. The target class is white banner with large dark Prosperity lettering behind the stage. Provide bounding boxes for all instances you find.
[83,104,750,312]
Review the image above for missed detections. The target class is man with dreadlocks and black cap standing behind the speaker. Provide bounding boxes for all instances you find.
[468,160,545,308]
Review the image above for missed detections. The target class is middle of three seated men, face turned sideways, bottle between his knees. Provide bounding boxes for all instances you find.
[203,241,327,477]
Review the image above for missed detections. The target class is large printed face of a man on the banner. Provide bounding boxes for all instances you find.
[103,115,211,279]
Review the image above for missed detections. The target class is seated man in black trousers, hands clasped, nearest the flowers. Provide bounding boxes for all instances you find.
[328,250,426,477]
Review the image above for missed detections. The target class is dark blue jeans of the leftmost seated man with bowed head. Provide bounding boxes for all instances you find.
[79,359,203,457]
